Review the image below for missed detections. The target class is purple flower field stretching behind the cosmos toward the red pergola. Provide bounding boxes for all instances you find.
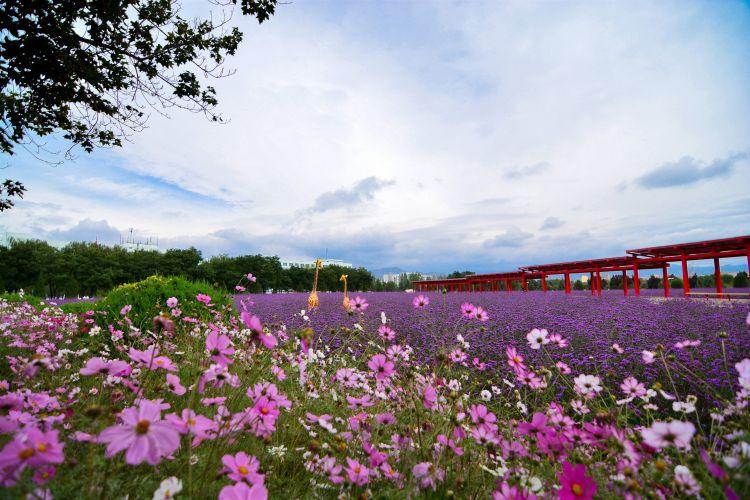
[245,290,750,396]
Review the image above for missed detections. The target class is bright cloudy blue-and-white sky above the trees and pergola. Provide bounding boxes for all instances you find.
[0,0,750,271]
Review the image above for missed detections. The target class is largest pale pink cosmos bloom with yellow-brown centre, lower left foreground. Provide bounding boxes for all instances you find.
[98,399,180,465]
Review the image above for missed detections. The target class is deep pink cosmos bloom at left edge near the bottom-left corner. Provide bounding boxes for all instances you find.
[0,426,65,486]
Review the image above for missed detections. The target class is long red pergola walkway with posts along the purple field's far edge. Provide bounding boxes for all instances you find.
[412,236,750,297]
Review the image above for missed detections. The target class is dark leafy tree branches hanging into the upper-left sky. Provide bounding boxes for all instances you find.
[0,0,276,203]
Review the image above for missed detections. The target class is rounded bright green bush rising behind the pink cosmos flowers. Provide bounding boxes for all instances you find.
[97,276,232,327]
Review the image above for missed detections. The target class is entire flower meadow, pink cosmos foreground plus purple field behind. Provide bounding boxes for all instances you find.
[0,275,750,500]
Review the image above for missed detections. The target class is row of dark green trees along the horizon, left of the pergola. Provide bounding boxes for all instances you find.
[0,240,375,297]
